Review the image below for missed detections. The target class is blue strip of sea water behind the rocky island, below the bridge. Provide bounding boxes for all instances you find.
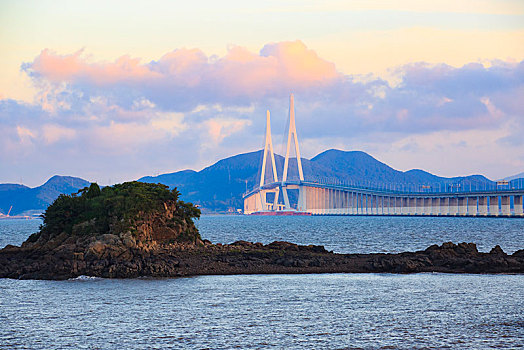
[0,215,524,254]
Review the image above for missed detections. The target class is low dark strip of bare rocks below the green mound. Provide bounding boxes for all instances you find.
[0,239,524,280]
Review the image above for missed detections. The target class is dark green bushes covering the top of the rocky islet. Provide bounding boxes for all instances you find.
[30,181,200,241]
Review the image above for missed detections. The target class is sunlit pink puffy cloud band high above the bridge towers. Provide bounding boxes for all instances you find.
[24,41,342,97]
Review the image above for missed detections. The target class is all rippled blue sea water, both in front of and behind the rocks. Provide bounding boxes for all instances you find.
[0,216,524,349]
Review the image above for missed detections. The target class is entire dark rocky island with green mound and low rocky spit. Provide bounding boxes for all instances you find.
[0,182,524,280]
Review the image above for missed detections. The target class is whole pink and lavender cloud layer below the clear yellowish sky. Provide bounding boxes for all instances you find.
[0,41,524,185]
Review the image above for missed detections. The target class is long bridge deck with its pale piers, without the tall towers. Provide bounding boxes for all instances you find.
[244,181,524,217]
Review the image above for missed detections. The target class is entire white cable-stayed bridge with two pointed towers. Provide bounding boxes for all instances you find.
[244,94,524,217]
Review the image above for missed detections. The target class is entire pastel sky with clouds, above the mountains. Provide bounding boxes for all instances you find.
[0,0,524,186]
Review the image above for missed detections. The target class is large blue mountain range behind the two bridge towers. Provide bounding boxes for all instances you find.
[139,149,492,211]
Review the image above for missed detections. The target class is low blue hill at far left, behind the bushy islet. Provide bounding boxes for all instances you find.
[0,175,90,215]
